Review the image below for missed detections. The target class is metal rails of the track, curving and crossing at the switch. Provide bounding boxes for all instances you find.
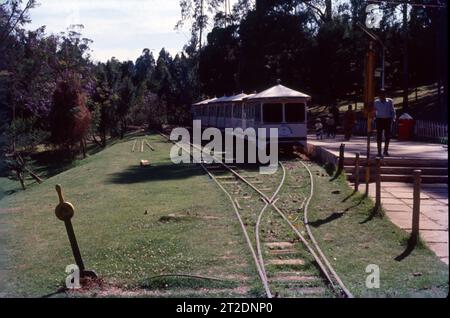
[160,132,353,298]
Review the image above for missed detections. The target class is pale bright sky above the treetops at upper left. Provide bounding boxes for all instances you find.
[27,0,190,62]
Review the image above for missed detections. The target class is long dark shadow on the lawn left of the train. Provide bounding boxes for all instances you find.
[109,163,205,184]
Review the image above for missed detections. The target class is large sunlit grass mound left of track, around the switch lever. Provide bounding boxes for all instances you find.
[0,136,253,296]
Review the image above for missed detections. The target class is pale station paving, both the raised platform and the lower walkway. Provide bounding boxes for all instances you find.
[307,135,449,264]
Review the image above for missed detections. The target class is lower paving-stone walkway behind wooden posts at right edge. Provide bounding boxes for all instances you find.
[360,182,449,265]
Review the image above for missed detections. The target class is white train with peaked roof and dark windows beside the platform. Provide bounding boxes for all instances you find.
[192,84,311,146]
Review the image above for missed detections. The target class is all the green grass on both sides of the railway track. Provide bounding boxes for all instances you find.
[0,135,448,297]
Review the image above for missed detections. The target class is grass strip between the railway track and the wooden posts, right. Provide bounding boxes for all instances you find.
[309,165,449,297]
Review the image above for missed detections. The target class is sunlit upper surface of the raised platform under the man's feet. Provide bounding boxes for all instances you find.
[308,135,448,160]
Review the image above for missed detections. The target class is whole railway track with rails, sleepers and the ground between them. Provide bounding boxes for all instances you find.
[161,133,353,298]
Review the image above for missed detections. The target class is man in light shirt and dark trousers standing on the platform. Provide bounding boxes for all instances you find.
[375,88,395,157]
